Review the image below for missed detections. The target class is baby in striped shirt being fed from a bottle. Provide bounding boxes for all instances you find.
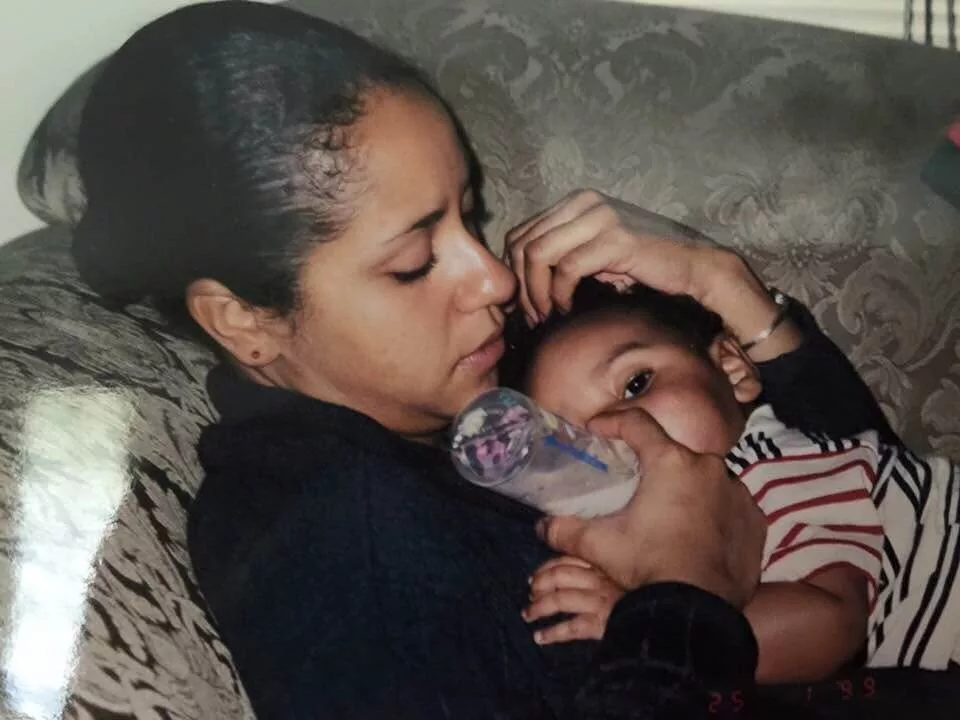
[512,280,960,683]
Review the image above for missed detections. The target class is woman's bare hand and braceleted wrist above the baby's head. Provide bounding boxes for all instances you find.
[505,190,801,361]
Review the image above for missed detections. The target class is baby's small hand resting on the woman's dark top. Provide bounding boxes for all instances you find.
[523,556,623,645]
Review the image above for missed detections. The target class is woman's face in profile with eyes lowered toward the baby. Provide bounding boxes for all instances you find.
[276,91,516,436]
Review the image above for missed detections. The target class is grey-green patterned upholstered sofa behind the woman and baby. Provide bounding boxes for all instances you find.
[0,0,960,720]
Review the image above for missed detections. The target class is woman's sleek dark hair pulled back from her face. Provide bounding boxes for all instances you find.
[73,0,468,328]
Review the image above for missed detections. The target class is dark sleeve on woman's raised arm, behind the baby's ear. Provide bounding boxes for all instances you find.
[757,301,901,445]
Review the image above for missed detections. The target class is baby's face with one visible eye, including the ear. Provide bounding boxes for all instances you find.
[528,315,760,455]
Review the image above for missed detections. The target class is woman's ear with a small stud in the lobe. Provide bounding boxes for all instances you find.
[186,279,281,368]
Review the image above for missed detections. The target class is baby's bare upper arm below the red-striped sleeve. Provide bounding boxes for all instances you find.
[744,566,869,683]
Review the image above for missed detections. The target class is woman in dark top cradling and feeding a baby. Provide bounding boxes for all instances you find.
[74,2,900,718]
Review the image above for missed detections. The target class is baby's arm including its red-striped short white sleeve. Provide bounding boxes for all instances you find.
[728,416,883,683]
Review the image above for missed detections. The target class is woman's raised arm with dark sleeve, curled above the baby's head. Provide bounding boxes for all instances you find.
[506,191,898,443]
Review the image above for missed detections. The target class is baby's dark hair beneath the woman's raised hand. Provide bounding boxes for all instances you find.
[500,278,723,392]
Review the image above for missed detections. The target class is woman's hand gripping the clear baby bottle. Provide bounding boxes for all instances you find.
[539,409,767,608]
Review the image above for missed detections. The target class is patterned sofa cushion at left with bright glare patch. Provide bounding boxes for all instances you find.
[0,228,252,720]
